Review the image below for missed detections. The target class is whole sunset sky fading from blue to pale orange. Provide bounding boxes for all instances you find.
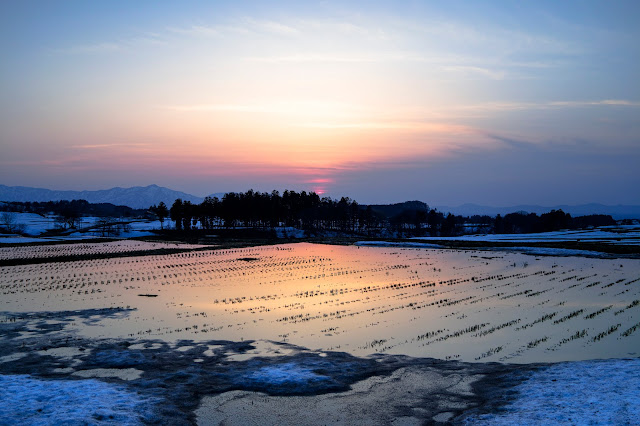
[0,0,640,206]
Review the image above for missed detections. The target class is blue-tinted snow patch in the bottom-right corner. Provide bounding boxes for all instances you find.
[465,358,640,425]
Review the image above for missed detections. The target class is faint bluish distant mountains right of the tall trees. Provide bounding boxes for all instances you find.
[434,203,640,219]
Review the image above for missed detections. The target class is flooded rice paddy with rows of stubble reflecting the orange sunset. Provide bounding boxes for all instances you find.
[0,243,640,363]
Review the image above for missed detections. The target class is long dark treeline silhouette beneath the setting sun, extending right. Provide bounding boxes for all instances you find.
[156,190,616,237]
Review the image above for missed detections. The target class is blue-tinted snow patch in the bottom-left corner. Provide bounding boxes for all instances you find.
[0,375,156,425]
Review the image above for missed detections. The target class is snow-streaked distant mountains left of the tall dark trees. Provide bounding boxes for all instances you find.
[0,185,204,209]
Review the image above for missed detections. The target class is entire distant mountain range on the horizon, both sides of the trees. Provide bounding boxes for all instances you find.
[0,185,640,219]
